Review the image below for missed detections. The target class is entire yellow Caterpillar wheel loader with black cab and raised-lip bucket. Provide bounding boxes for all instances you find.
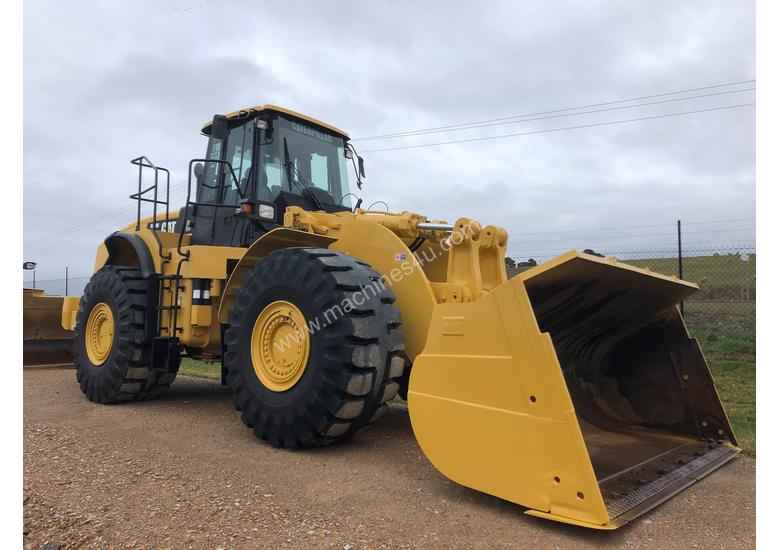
[62,105,739,529]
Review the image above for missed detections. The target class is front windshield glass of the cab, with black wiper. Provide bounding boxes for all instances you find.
[257,117,352,207]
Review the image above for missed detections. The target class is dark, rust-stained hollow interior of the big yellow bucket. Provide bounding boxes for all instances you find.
[525,256,736,521]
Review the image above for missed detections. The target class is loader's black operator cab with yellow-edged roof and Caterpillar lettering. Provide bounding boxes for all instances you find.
[188,105,354,246]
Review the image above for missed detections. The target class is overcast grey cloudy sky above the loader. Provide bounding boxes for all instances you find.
[24,0,755,280]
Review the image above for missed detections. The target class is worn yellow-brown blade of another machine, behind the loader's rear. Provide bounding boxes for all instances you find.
[22,288,73,367]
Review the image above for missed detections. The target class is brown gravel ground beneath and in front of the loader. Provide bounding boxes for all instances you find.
[24,370,755,549]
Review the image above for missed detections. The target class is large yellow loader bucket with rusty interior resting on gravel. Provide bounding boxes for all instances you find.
[408,251,739,529]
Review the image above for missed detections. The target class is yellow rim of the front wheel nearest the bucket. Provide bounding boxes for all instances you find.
[251,300,310,392]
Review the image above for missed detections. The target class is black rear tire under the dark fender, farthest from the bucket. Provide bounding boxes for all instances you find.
[73,266,181,403]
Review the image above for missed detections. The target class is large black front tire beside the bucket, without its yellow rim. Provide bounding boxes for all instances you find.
[224,248,404,448]
